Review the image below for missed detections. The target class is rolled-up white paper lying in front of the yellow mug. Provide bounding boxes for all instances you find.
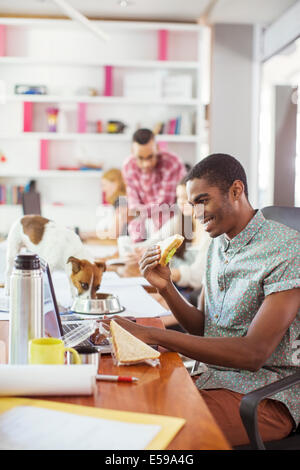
[0,364,97,396]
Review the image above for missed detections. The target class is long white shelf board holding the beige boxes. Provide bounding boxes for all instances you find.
[0,95,200,106]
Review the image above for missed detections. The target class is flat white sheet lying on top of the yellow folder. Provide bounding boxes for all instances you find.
[0,406,161,450]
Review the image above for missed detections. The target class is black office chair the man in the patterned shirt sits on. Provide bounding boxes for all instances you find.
[235,206,300,450]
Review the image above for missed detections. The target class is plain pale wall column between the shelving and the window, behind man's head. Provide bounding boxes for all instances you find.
[210,24,260,206]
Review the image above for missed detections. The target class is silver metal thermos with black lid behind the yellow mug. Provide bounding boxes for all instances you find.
[9,254,44,364]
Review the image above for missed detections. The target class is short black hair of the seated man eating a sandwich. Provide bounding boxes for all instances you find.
[186,153,248,198]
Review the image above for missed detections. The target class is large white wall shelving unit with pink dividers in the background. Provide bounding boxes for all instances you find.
[0,18,210,233]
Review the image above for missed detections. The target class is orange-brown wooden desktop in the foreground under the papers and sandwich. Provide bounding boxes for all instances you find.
[0,318,230,450]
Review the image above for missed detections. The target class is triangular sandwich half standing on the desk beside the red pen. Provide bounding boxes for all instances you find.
[110,320,160,365]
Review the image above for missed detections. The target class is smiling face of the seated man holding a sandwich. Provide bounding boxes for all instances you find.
[187,178,237,238]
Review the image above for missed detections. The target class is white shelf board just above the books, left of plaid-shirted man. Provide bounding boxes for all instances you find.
[0,170,102,179]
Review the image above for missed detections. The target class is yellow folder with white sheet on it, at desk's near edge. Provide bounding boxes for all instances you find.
[0,398,185,450]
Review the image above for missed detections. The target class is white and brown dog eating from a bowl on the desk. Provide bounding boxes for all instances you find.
[5,215,106,299]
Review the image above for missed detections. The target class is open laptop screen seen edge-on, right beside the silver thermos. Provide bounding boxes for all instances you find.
[40,259,63,338]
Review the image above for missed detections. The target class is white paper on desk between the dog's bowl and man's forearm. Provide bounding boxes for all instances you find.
[100,284,170,318]
